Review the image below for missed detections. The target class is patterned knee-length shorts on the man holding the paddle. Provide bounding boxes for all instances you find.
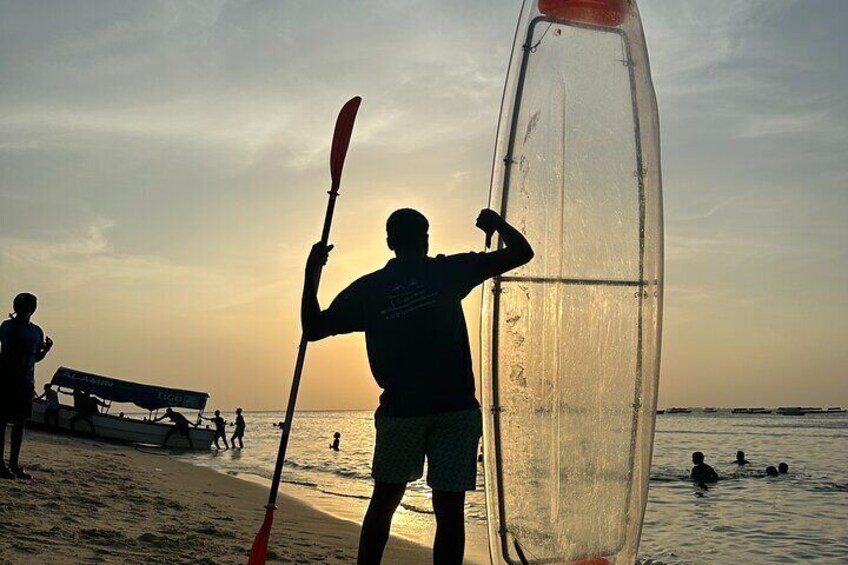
[371,408,483,492]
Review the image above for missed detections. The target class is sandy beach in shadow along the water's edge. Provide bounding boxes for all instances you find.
[0,430,432,565]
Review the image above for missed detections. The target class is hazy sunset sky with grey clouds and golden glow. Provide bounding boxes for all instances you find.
[0,0,848,411]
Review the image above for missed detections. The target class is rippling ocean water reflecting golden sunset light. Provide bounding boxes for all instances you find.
[178,411,848,565]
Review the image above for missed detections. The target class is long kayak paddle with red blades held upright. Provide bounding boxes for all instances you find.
[247,96,362,565]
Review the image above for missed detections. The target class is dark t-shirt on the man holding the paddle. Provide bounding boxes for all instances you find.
[322,253,497,416]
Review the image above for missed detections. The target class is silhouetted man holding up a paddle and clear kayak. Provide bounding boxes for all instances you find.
[301,208,533,565]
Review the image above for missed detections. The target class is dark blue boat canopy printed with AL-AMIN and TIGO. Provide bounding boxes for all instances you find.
[50,367,209,410]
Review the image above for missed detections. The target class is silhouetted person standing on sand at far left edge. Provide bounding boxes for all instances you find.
[0,292,53,480]
